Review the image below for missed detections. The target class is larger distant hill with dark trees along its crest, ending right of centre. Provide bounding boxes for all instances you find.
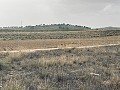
[1,23,91,31]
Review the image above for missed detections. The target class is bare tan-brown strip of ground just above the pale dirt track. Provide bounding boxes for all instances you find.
[0,36,120,51]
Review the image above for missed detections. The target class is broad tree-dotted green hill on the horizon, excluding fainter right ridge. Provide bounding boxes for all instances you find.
[1,23,91,32]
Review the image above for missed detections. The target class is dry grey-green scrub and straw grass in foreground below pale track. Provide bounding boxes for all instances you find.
[0,45,120,90]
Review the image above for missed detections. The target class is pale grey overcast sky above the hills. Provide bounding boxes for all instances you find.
[0,0,120,28]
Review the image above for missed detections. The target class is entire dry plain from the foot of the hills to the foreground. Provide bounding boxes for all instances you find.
[0,31,120,90]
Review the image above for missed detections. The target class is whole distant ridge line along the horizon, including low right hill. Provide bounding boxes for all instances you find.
[0,23,120,31]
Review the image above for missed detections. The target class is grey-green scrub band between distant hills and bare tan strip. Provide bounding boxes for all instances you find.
[0,30,120,40]
